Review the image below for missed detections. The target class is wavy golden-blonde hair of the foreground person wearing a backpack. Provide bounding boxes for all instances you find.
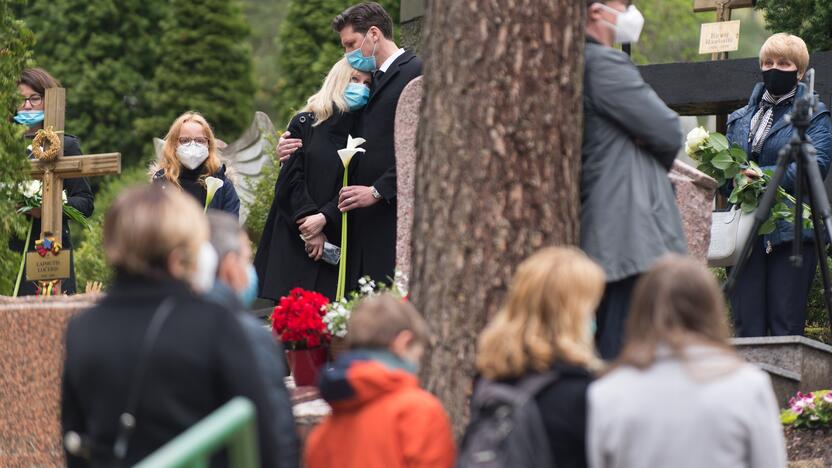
[477,247,604,379]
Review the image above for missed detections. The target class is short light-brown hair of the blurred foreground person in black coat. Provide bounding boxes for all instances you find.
[103,185,208,277]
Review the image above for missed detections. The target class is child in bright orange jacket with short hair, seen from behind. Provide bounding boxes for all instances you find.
[305,295,456,468]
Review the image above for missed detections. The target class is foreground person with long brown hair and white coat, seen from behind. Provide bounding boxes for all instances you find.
[587,256,786,468]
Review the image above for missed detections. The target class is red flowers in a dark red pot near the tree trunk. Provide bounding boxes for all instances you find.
[271,288,331,387]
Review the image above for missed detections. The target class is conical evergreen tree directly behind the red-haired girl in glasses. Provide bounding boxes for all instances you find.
[136,0,254,146]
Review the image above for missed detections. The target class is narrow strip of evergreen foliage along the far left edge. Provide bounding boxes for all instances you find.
[0,0,34,295]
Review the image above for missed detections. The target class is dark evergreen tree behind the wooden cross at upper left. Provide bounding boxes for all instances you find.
[26,0,168,165]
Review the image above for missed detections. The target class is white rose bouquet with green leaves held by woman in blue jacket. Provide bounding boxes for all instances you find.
[685,127,812,235]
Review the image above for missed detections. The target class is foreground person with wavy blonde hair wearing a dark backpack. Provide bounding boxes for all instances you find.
[459,247,604,468]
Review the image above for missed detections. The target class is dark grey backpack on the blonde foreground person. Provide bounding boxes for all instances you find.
[457,371,558,468]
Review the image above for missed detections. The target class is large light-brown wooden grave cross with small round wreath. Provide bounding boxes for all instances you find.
[26,88,121,294]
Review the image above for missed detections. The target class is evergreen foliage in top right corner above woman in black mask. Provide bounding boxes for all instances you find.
[757,0,832,52]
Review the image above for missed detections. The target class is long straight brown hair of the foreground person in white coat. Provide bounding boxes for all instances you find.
[615,255,735,369]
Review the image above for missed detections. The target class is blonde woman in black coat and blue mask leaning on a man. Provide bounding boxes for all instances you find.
[254,59,371,300]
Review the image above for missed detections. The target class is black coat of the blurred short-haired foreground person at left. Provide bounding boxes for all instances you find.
[61,276,278,468]
